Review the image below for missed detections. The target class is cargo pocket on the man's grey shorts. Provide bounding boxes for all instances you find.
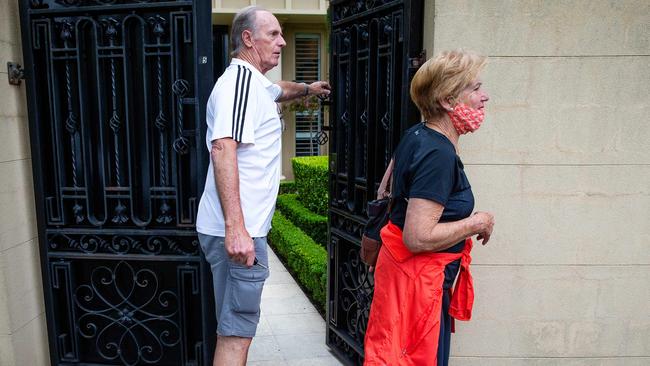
[229,266,269,314]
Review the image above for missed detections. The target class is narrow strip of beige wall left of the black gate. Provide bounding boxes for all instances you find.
[0,0,49,366]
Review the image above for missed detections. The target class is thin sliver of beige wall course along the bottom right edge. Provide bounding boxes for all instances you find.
[449,358,650,366]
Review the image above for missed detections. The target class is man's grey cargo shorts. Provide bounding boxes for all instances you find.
[199,233,269,338]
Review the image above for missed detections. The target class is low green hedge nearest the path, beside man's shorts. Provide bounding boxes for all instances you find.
[268,211,327,312]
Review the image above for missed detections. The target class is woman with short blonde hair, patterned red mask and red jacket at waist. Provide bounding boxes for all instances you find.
[365,51,494,366]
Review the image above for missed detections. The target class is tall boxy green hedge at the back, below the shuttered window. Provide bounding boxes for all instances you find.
[291,156,329,215]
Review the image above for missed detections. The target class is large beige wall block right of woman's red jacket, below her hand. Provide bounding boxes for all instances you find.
[452,266,650,357]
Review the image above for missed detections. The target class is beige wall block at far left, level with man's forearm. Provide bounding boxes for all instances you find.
[0,160,36,252]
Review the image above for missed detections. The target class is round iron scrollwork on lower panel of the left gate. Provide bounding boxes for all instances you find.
[74,261,181,365]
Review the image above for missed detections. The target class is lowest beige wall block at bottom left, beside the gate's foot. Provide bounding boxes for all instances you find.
[11,315,50,366]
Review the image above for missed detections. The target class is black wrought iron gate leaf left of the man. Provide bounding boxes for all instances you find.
[20,0,214,366]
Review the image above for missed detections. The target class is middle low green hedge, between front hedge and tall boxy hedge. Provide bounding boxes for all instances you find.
[277,194,327,248]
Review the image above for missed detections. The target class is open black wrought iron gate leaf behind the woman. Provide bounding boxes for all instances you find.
[327,0,424,364]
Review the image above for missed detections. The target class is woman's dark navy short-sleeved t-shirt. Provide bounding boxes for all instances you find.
[390,123,474,288]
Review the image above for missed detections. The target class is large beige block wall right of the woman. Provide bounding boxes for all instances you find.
[424,0,650,366]
